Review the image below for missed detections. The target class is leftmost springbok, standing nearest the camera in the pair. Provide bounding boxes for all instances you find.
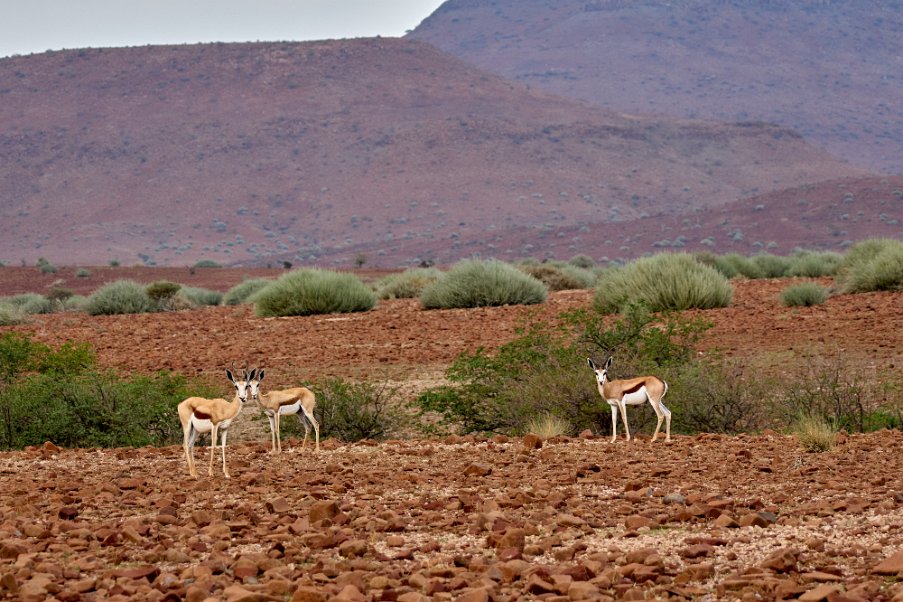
[179,369,248,479]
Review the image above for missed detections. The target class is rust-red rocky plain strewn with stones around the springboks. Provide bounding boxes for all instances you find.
[0,268,903,602]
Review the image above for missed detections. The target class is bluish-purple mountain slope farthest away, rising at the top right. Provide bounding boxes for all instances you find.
[410,0,903,173]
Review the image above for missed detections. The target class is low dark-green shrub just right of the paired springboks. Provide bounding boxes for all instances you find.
[282,378,406,442]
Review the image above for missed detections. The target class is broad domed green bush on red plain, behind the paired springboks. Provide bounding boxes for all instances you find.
[249,269,376,317]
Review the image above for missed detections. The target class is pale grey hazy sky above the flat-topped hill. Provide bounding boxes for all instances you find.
[0,0,443,57]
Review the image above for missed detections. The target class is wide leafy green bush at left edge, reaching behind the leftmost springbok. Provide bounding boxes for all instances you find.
[0,333,213,449]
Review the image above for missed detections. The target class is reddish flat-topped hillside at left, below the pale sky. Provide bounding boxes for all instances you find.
[0,39,864,266]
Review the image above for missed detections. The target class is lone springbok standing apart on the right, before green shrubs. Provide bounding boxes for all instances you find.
[586,357,671,443]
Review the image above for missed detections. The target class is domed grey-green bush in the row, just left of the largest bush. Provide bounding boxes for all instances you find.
[420,259,548,309]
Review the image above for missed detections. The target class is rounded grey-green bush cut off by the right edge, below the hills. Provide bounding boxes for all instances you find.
[836,238,903,293]
